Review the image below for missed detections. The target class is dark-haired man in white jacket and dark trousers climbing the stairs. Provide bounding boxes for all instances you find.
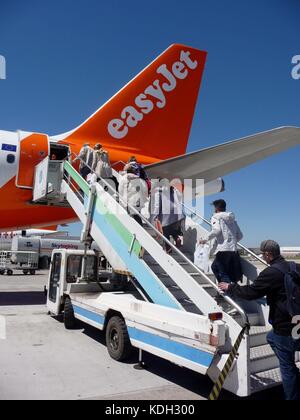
[200,200,243,283]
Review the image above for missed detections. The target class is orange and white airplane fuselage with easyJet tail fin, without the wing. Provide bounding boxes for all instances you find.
[0,44,207,232]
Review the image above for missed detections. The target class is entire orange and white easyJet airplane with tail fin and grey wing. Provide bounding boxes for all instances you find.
[0,44,300,231]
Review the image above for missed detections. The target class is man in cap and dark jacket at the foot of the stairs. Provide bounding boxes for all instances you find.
[219,240,300,401]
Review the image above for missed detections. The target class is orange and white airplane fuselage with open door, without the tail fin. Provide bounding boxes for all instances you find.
[0,131,157,232]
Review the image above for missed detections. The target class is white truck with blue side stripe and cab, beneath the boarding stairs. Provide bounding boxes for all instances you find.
[47,250,226,373]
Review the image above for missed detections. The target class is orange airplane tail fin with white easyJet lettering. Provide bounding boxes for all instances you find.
[60,44,207,164]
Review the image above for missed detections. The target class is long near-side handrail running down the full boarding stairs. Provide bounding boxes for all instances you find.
[67,152,249,325]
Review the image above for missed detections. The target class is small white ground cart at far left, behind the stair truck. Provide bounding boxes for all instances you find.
[0,251,39,276]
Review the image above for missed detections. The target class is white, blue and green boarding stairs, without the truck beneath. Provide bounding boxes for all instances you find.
[34,161,298,396]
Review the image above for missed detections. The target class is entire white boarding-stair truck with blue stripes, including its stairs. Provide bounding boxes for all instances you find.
[37,158,299,396]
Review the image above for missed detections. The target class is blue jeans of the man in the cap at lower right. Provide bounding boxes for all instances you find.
[268,331,300,401]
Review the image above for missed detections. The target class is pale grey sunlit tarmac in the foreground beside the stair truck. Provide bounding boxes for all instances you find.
[0,272,282,401]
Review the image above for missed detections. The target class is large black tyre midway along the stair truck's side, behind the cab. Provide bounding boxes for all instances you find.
[106,316,132,362]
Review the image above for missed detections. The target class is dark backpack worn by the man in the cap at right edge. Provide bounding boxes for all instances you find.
[272,262,300,317]
